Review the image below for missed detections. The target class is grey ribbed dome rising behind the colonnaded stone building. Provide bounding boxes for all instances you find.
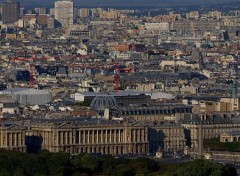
[90,95,118,114]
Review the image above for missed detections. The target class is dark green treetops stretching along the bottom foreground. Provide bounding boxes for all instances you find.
[0,150,236,176]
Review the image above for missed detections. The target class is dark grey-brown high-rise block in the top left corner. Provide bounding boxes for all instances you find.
[2,0,20,24]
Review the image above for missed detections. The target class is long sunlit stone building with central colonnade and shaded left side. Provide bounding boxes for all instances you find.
[26,119,148,155]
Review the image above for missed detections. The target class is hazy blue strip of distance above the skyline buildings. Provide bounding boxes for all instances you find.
[20,0,240,7]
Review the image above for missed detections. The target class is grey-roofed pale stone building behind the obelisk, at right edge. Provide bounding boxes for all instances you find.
[180,113,240,150]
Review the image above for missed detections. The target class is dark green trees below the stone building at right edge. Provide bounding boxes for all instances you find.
[203,138,240,152]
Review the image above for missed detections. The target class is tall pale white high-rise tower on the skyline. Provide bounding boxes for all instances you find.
[55,0,73,27]
